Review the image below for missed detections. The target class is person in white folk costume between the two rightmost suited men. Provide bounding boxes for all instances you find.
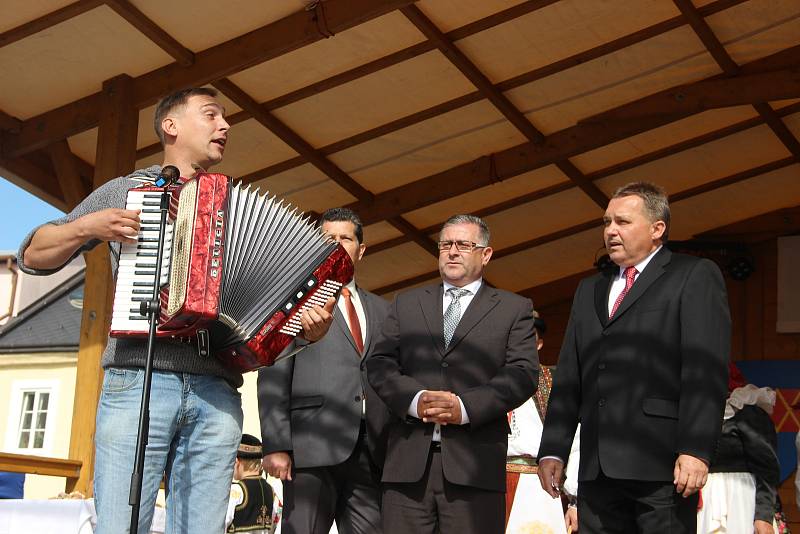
[506,311,577,534]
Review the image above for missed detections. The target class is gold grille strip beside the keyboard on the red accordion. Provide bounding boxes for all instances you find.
[167,180,197,315]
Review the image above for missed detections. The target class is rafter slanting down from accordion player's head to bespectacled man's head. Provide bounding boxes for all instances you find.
[213,78,439,256]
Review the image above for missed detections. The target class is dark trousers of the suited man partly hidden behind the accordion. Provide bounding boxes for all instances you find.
[281,425,381,534]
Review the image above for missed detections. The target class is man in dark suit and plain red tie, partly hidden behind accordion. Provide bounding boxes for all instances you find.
[258,208,389,534]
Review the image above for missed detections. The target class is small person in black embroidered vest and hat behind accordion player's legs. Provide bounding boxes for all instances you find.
[226,434,281,534]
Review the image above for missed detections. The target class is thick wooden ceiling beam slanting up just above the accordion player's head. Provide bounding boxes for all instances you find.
[4,0,413,157]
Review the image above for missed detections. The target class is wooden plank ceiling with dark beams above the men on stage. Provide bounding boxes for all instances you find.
[0,0,800,300]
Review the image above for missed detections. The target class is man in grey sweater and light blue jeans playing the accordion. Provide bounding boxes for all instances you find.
[17,88,333,534]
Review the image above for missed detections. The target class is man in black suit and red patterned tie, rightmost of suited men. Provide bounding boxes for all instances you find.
[539,183,731,534]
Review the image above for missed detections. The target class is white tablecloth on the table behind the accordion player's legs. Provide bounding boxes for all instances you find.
[0,499,165,534]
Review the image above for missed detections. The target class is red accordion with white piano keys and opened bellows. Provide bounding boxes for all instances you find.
[111,173,353,371]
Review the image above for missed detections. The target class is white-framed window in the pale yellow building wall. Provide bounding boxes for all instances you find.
[5,380,59,456]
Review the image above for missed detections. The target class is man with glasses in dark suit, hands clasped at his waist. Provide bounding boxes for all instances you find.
[367,215,539,534]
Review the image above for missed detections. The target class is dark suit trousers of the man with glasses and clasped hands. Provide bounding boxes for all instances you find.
[383,445,505,534]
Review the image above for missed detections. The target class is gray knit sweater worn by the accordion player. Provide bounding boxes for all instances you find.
[17,165,242,388]
